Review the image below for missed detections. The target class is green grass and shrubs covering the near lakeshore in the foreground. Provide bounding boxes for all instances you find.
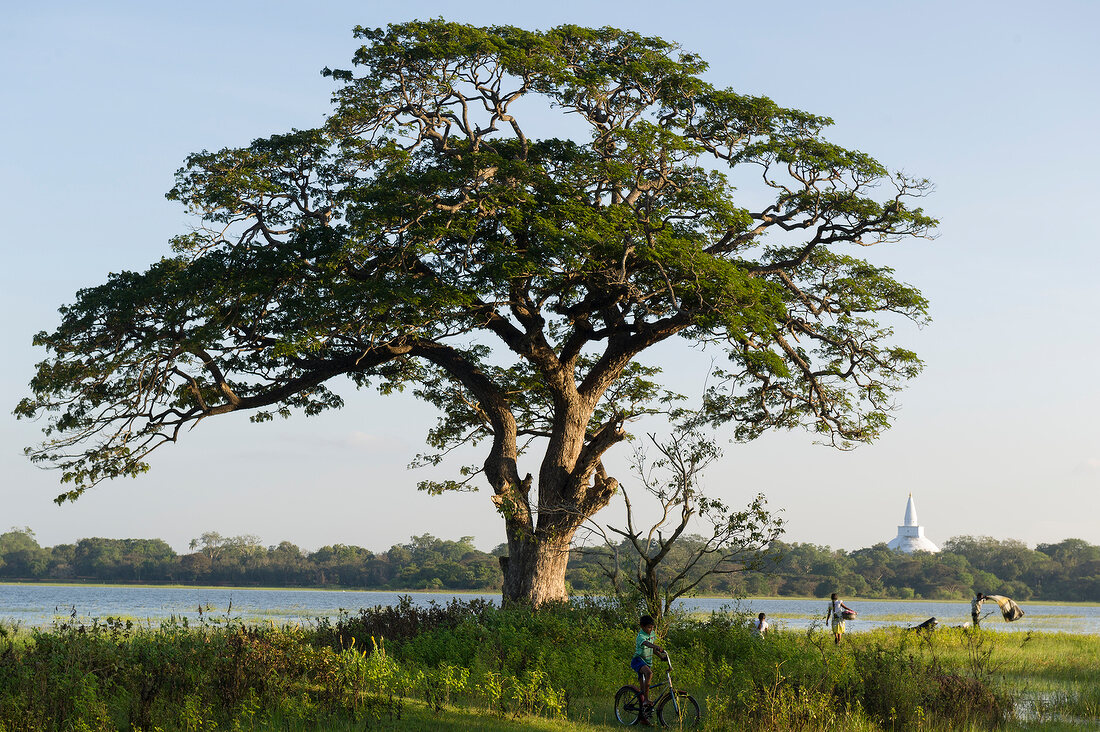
[0,601,1100,732]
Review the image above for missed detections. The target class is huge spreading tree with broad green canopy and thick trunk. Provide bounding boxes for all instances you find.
[17,20,935,603]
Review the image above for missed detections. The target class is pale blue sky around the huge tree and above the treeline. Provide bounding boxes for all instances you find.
[0,0,1100,550]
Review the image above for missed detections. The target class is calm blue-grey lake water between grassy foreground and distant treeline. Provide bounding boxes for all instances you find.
[0,583,1100,634]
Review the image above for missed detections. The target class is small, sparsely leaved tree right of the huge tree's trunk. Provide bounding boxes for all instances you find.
[582,426,784,620]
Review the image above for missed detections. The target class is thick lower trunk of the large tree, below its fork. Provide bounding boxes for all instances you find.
[501,532,573,607]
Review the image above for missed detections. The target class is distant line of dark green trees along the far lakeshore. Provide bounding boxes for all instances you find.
[0,528,1100,601]
